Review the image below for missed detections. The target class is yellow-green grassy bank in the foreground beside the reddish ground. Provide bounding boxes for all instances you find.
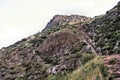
[47,56,109,80]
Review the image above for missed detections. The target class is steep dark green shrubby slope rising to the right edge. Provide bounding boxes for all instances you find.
[85,2,120,54]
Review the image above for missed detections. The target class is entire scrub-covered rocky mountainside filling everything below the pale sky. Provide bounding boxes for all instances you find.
[0,2,120,80]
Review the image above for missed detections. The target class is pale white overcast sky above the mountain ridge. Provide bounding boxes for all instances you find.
[0,0,119,48]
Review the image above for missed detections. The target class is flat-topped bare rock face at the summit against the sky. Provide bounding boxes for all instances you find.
[46,15,91,28]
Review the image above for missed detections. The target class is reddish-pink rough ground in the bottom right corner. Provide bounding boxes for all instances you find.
[104,55,120,80]
